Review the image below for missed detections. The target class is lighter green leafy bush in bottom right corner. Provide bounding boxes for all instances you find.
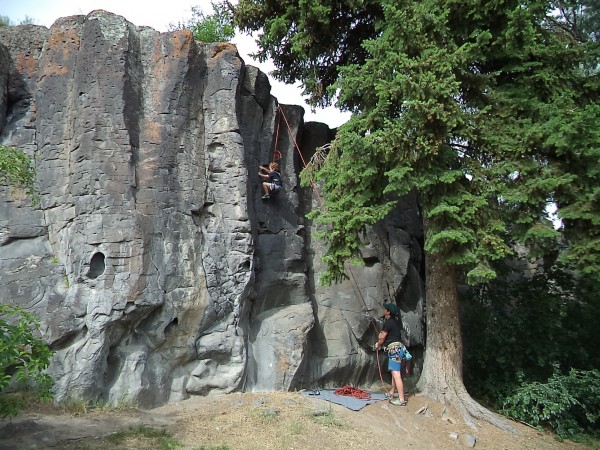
[503,369,600,438]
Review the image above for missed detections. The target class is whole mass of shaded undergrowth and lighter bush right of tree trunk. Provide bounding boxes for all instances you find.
[462,266,600,438]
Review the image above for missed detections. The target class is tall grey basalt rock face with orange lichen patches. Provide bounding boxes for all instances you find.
[0,11,423,406]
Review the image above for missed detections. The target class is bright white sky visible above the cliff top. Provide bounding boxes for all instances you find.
[0,0,350,128]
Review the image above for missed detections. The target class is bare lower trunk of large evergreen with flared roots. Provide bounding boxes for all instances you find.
[417,254,516,432]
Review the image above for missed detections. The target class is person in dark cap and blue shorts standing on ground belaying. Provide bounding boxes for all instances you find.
[375,303,409,406]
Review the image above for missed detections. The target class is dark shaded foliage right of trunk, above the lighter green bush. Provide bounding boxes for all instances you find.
[461,267,600,407]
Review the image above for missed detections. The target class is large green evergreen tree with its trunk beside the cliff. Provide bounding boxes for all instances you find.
[236,0,600,427]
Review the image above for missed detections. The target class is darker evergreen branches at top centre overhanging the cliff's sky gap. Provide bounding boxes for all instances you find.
[234,0,381,106]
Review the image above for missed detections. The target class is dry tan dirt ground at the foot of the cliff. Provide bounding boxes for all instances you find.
[0,392,588,450]
